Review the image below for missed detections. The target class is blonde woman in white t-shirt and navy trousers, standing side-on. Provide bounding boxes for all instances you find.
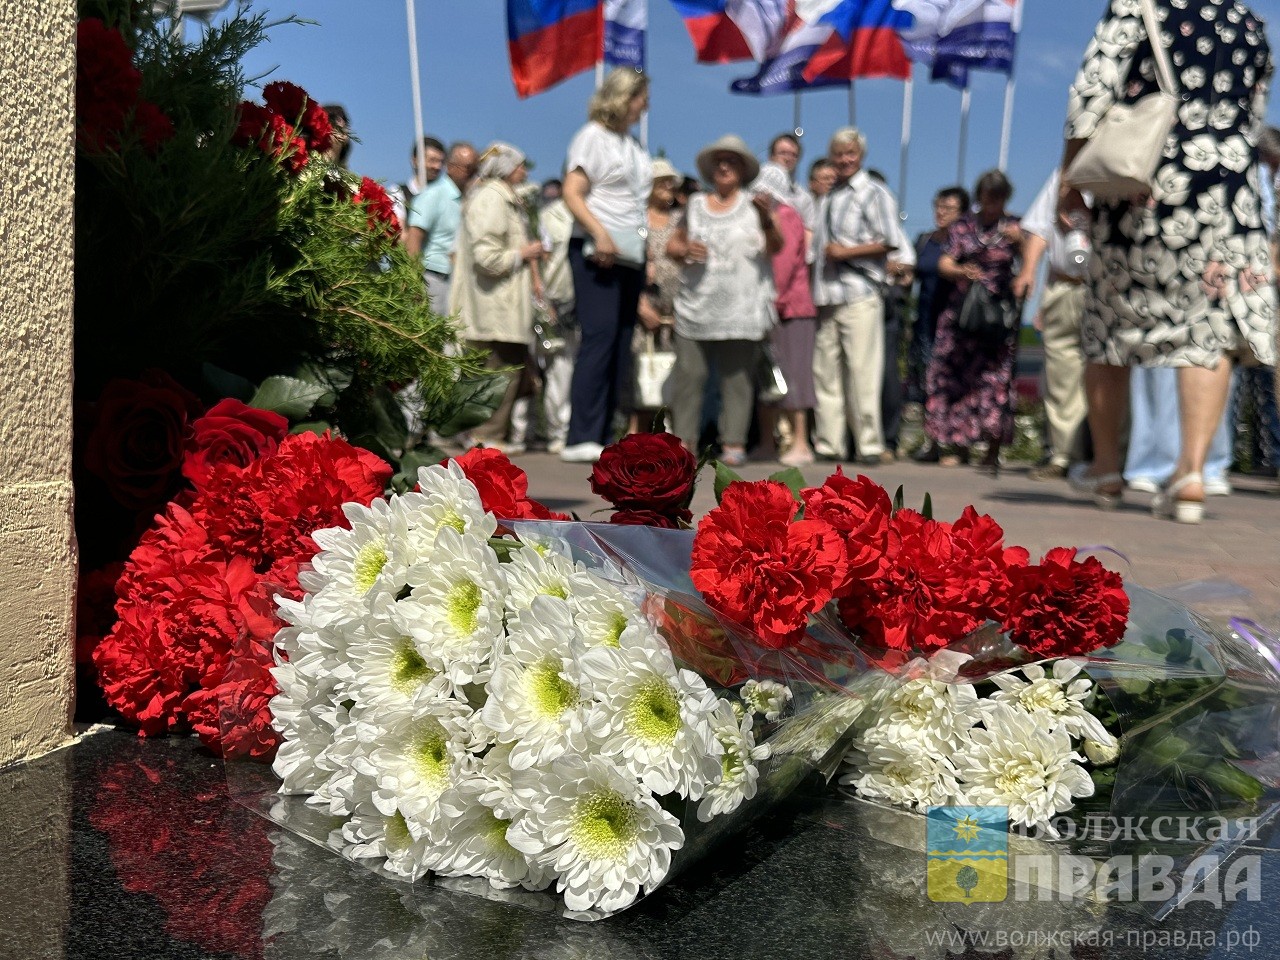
[561,68,650,463]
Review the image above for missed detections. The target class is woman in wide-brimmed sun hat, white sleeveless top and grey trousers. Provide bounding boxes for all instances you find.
[667,136,782,466]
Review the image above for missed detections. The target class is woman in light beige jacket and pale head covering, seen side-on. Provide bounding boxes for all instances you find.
[449,142,543,453]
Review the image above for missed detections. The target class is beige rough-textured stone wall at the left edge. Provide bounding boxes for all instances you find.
[0,0,76,765]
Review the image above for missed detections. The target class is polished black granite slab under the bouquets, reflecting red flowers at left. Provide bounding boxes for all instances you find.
[0,731,1280,960]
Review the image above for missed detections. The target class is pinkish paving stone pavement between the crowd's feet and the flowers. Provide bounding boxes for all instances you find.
[499,453,1280,627]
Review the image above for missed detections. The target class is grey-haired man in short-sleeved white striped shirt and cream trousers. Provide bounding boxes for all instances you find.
[813,127,901,463]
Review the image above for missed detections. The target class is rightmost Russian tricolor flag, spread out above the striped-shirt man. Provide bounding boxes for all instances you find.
[796,0,913,83]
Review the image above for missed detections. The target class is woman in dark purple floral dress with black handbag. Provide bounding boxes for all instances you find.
[924,170,1023,474]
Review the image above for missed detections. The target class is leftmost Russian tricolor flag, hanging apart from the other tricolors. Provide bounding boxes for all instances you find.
[507,0,604,97]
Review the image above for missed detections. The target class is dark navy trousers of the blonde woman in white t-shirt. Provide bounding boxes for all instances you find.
[566,239,644,447]
